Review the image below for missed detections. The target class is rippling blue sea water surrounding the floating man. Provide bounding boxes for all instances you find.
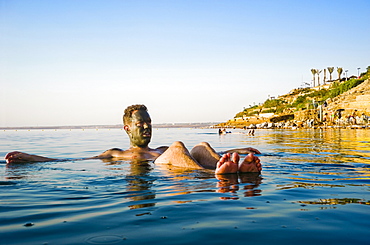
[0,128,370,244]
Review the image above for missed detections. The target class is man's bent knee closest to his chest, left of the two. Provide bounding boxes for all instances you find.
[154,141,202,169]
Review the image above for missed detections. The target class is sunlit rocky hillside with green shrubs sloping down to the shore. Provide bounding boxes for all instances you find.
[216,66,370,128]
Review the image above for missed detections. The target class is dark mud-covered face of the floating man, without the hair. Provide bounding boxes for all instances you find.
[125,110,152,147]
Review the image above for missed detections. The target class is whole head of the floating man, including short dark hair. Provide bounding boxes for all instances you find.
[123,105,152,147]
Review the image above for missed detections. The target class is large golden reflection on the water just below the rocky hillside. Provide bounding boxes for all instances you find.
[266,129,370,164]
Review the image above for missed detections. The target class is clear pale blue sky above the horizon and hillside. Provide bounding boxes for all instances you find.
[0,0,370,126]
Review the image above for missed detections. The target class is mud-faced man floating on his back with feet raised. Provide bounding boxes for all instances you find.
[5,105,262,174]
